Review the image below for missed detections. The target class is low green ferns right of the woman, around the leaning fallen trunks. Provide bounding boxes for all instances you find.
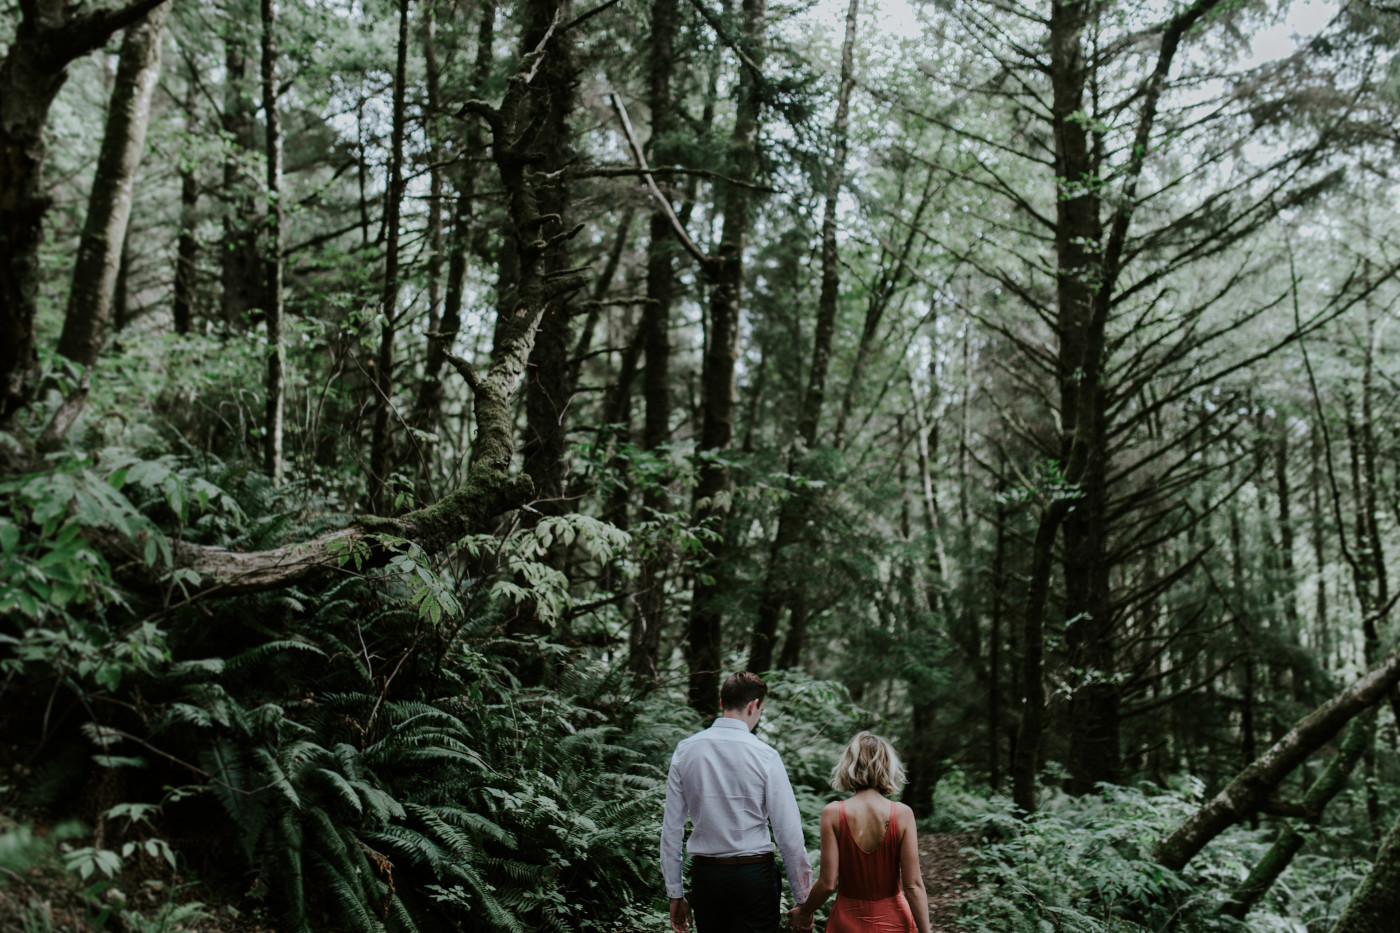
[932,780,1365,933]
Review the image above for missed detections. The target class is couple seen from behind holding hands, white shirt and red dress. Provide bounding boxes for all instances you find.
[661,671,928,933]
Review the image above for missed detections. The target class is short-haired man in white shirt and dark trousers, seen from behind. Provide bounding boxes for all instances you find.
[661,671,812,933]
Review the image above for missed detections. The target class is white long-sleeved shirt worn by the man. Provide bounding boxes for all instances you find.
[661,717,812,904]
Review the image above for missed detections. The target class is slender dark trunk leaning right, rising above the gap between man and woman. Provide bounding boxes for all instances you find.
[749,0,860,671]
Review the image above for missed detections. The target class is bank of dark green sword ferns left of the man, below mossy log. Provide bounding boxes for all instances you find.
[144,554,689,932]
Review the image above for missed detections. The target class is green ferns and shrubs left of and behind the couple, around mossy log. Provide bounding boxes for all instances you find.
[0,378,884,933]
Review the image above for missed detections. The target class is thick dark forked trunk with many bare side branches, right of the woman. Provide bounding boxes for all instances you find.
[1041,0,1219,793]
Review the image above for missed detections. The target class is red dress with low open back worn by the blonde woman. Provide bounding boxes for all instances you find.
[826,800,918,933]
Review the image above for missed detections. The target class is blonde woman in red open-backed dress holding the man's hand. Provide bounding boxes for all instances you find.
[788,733,928,933]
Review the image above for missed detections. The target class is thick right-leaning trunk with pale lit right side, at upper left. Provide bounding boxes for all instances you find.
[59,6,169,366]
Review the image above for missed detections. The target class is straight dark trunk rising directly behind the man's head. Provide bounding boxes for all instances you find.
[687,0,767,716]
